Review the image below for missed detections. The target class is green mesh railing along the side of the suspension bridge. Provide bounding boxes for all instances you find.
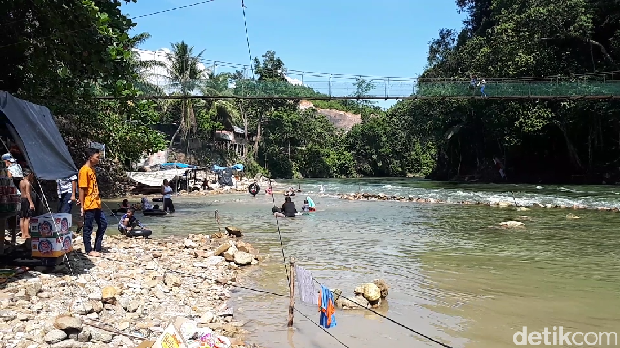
[140,76,620,99]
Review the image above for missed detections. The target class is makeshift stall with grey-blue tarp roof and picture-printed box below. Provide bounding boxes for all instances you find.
[0,91,77,259]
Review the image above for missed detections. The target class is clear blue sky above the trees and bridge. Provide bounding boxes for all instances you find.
[122,0,465,106]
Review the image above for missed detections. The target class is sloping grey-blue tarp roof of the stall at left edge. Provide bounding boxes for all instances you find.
[0,91,77,180]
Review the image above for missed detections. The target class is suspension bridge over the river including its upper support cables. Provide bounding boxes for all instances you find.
[108,63,620,100]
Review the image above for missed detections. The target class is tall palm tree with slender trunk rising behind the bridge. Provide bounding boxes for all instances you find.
[165,41,206,147]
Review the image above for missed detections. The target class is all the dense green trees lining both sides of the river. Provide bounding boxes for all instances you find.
[0,0,620,182]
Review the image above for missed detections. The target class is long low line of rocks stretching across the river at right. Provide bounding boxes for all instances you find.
[338,193,620,213]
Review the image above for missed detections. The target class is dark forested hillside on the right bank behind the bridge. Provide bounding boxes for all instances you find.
[388,0,620,183]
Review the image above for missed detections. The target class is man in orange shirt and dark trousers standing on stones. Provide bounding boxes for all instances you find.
[78,149,108,256]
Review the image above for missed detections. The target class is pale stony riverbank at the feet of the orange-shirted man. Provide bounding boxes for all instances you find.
[0,228,263,348]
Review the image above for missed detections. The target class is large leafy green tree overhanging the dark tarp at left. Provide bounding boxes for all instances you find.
[0,0,164,161]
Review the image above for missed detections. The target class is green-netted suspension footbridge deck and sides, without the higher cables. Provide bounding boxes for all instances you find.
[99,78,620,100]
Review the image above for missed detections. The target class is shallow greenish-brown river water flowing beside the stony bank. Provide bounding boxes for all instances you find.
[111,179,620,348]
